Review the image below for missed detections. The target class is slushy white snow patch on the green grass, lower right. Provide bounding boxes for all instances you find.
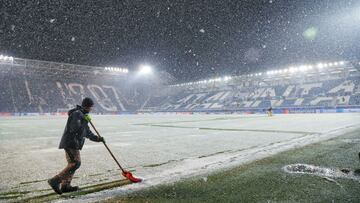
[283,164,360,181]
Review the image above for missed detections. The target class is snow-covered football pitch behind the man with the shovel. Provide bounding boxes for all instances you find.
[0,113,360,200]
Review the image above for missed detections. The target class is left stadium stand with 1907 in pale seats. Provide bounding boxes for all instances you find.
[0,59,152,114]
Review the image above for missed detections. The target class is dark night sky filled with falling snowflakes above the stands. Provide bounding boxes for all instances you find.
[0,0,360,81]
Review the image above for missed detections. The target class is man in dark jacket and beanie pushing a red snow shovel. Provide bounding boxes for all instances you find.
[48,98,105,194]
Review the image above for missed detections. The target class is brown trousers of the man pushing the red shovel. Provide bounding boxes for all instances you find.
[55,149,81,187]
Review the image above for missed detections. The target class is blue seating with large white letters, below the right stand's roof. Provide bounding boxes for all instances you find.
[142,77,360,111]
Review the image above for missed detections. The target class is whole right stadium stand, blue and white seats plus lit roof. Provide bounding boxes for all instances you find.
[145,63,360,112]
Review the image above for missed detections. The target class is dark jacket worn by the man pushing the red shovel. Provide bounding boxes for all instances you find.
[59,105,100,150]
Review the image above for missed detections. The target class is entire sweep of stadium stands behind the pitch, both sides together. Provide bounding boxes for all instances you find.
[0,58,360,115]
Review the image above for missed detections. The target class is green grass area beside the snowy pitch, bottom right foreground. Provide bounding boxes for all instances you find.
[106,130,360,202]
